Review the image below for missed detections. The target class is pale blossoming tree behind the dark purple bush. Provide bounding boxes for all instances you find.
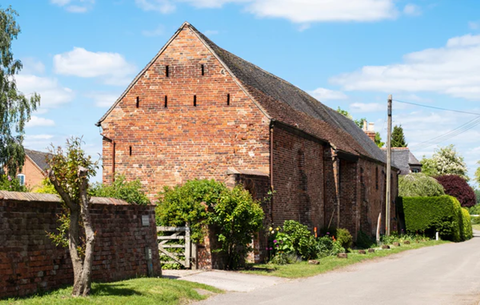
[420,144,469,181]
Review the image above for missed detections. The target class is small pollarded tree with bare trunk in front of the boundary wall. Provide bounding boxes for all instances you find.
[47,138,97,296]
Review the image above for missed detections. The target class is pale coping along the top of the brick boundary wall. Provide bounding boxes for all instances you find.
[0,191,154,205]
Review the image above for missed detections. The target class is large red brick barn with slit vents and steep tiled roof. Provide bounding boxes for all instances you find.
[97,23,397,242]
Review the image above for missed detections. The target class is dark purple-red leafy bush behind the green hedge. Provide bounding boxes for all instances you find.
[435,175,476,208]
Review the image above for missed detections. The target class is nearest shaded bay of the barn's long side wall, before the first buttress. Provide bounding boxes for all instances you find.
[273,127,324,229]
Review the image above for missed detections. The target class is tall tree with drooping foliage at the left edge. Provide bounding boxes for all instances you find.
[0,7,40,176]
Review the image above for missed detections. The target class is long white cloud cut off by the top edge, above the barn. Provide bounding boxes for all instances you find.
[135,0,398,23]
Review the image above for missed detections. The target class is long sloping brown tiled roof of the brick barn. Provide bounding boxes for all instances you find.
[188,25,386,163]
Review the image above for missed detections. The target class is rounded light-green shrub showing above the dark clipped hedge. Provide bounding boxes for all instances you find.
[398,173,445,197]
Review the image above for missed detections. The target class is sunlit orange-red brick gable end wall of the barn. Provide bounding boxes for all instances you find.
[102,28,270,198]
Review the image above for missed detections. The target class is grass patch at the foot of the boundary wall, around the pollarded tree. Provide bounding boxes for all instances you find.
[0,278,221,305]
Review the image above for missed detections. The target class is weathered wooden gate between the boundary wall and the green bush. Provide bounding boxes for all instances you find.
[157,226,197,269]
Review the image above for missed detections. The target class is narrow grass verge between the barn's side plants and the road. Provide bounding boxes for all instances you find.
[243,240,449,278]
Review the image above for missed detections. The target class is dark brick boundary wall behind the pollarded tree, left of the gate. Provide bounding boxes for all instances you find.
[0,191,161,298]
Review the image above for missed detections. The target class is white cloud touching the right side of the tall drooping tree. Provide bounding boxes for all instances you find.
[15,74,75,108]
